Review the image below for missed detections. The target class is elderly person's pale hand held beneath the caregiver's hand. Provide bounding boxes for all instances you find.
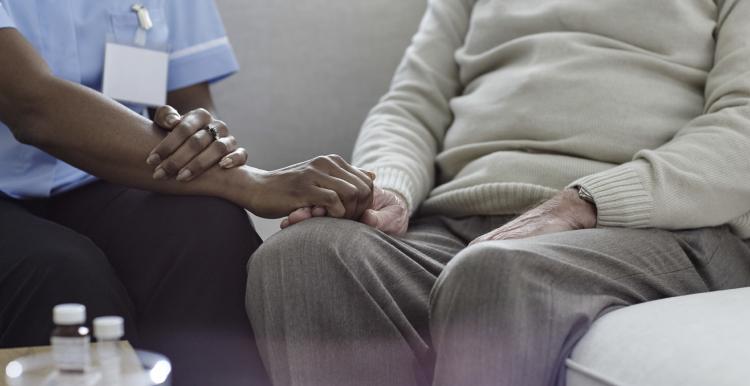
[281,186,409,235]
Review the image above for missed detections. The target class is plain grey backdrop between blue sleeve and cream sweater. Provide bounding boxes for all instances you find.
[214,0,425,168]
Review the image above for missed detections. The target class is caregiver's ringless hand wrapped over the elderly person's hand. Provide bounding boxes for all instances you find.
[244,155,373,220]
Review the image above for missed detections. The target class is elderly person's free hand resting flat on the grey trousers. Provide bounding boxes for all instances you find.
[471,189,596,244]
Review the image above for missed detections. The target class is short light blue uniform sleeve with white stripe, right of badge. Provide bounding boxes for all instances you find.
[166,0,239,91]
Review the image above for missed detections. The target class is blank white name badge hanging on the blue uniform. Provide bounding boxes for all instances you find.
[102,43,169,106]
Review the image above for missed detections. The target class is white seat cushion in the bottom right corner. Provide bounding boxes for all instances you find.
[567,288,750,386]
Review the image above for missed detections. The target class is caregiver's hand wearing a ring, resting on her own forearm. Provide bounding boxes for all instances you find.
[146,106,247,182]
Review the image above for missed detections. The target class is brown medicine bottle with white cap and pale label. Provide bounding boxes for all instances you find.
[50,304,91,373]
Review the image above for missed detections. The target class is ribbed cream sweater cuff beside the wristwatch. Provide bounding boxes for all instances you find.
[569,163,654,228]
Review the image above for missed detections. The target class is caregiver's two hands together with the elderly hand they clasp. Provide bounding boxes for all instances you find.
[146,106,409,234]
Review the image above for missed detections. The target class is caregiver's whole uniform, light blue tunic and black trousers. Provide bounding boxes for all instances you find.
[0,0,265,386]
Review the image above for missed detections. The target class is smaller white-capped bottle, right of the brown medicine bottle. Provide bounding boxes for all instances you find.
[94,316,125,386]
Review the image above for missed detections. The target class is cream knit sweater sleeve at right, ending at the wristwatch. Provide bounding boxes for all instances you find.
[572,0,750,237]
